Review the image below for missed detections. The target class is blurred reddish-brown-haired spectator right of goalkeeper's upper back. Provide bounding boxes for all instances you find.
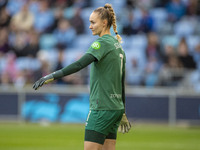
[146,32,163,62]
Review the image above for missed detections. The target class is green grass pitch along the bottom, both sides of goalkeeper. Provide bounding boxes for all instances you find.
[0,123,200,150]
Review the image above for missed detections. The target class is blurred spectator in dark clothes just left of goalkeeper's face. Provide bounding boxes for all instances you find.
[70,8,85,34]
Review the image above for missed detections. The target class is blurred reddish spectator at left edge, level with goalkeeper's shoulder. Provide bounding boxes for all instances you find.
[0,28,10,54]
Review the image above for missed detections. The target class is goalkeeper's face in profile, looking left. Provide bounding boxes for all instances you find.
[89,12,105,36]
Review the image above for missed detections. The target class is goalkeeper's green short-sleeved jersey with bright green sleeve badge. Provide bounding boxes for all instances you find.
[86,34,126,110]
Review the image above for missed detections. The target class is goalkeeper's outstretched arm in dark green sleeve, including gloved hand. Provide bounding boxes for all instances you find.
[33,53,96,90]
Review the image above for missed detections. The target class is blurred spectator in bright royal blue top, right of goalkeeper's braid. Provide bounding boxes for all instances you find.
[138,8,154,33]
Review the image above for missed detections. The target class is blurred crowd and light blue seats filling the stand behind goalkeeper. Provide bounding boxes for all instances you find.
[0,0,200,91]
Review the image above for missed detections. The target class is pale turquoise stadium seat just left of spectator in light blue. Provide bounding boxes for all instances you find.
[40,34,57,50]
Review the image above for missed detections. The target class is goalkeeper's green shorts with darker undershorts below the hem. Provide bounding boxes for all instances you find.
[85,110,124,144]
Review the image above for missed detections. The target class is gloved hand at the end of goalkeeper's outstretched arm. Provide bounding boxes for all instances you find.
[33,74,54,90]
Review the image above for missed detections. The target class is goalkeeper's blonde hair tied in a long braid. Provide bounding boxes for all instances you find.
[94,3,122,43]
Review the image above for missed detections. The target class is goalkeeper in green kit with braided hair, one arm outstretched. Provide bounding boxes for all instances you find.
[33,4,131,150]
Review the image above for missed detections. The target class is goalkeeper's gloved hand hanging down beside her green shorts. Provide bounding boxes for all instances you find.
[118,113,131,133]
